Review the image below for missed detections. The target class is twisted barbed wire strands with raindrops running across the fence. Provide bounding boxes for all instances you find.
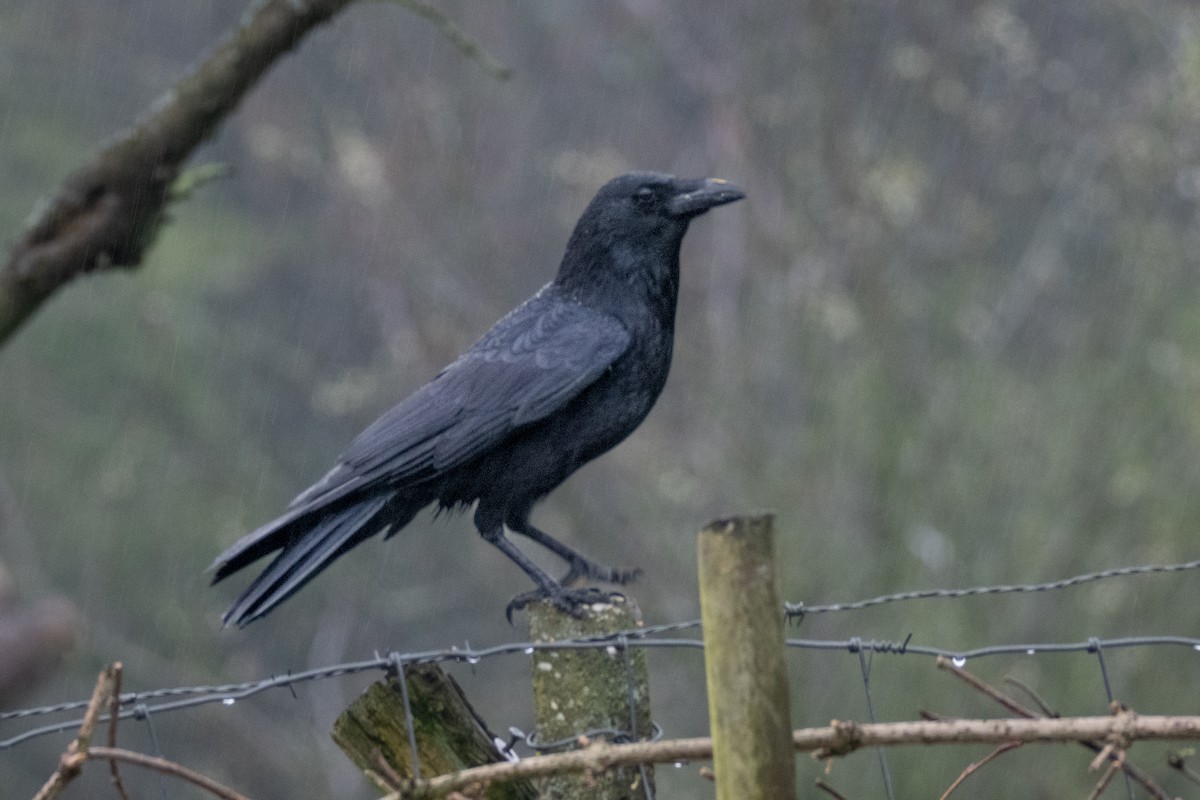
[0,560,1200,752]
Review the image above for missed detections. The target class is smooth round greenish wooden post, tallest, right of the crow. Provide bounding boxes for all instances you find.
[698,515,796,800]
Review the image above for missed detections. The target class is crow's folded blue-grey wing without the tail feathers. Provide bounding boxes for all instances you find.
[292,297,630,510]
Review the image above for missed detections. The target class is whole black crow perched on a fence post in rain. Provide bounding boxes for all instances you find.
[211,173,744,626]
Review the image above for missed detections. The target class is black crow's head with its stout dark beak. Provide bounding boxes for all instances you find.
[558,172,745,296]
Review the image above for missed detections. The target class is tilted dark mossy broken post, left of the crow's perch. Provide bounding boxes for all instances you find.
[332,664,535,800]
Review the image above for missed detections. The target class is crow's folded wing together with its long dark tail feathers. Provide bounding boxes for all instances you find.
[211,296,630,624]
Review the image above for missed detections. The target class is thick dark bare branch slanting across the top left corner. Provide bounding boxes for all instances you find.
[0,0,354,343]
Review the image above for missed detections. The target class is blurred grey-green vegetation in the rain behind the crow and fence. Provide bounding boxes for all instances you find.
[0,0,1200,800]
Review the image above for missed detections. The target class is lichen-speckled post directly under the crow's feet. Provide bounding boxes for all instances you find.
[528,596,654,800]
